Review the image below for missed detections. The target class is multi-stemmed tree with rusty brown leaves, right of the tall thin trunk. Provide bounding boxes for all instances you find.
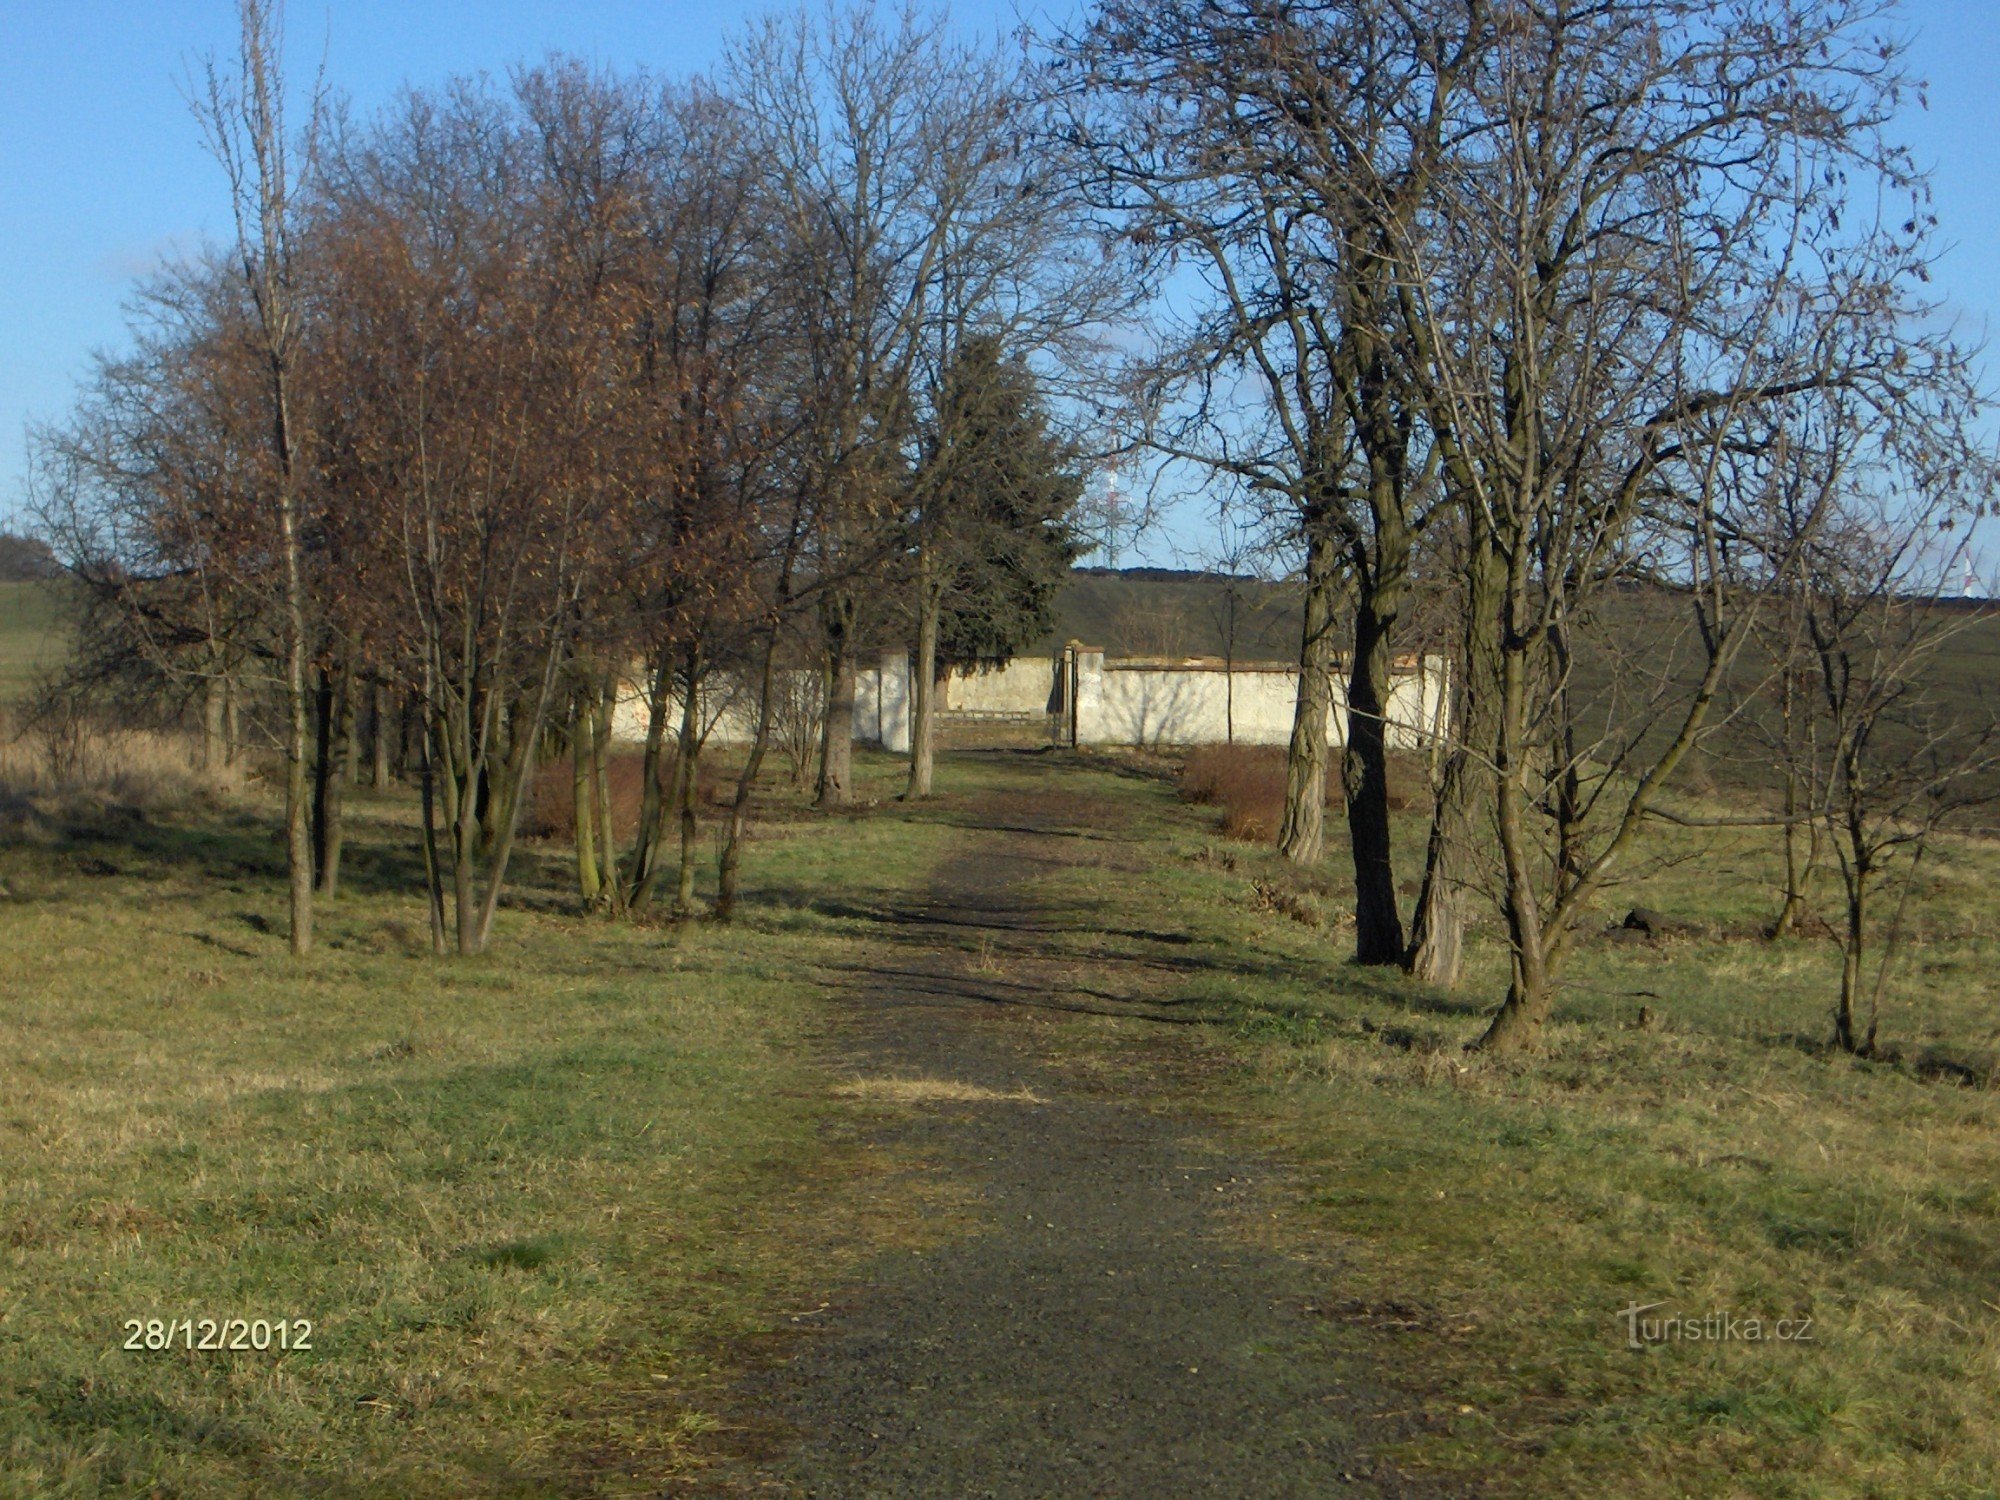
[326,86,632,952]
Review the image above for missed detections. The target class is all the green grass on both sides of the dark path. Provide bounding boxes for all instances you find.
[0,716,2000,1496]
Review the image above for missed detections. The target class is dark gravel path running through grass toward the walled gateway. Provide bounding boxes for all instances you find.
[702,780,1472,1500]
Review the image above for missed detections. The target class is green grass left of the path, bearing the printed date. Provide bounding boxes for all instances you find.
[0,768,956,1496]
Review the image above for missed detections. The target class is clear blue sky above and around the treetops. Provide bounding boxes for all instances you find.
[0,0,2000,572]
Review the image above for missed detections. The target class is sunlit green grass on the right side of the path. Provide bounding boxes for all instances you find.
[1044,764,2000,1496]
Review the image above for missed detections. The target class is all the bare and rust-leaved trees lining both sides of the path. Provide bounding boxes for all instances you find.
[19,0,1986,1048]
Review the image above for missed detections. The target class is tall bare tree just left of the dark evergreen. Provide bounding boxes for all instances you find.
[726,6,1076,806]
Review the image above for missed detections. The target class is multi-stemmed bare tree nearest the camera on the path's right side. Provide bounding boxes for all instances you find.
[1398,0,1964,1050]
